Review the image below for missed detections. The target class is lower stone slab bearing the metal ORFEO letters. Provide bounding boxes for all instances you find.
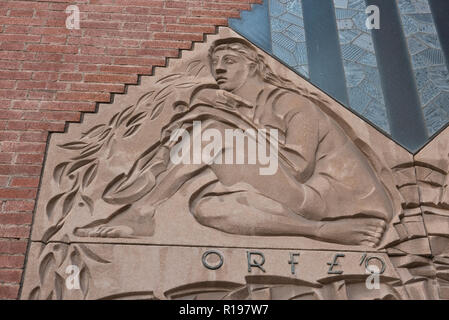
[22,243,406,299]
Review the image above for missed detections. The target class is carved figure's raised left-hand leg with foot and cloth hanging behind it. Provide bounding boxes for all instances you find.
[75,120,220,238]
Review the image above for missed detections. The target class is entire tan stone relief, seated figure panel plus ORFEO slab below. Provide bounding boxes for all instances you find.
[22,29,449,299]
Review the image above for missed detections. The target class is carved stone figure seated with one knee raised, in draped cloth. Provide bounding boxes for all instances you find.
[76,38,400,246]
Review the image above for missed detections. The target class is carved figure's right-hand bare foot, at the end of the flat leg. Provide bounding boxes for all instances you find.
[318,218,386,247]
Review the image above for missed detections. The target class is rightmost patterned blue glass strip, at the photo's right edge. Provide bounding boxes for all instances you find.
[398,0,449,135]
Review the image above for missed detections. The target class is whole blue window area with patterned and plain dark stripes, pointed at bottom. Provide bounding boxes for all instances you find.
[230,0,449,151]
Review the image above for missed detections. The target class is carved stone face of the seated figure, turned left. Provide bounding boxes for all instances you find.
[211,49,251,92]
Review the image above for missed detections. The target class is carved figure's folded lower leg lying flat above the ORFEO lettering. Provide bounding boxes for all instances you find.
[192,186,386,247]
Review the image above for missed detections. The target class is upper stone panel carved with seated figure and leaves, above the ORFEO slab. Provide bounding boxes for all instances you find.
[26,28,408,249]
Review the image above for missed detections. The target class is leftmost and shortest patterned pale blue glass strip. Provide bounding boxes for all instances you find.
[269,0,309,77]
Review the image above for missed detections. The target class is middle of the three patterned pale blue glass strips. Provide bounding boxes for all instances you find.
[334,0,390,132]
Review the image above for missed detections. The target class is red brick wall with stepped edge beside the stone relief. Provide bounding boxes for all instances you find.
[0,0,261,299]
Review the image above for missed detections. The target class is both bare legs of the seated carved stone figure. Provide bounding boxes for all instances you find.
[82,117,385,246]
